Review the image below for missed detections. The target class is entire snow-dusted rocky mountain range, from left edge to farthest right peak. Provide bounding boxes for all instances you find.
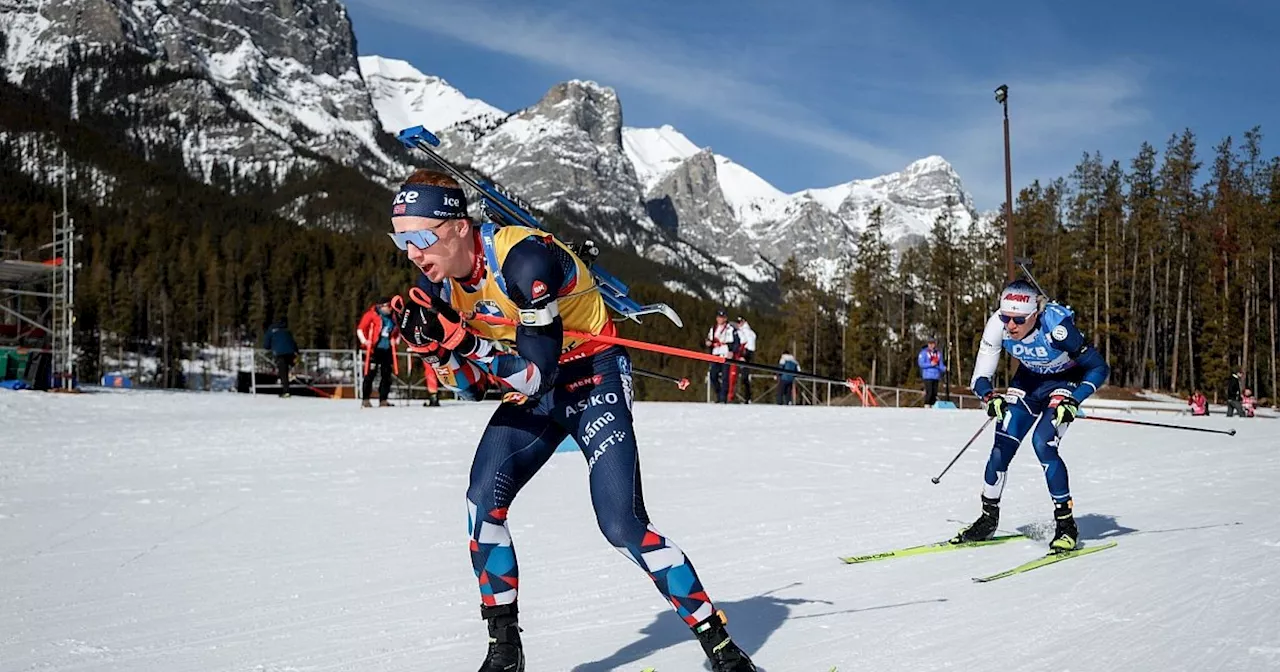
[0,0,969,302]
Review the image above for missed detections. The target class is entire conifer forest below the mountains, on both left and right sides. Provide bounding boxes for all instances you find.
[0,68,1280,403]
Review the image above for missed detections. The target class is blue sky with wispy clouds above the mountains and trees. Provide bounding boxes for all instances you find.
[348,0,1280,210]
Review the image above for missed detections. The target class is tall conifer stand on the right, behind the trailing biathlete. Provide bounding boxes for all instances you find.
[782,128,1280,403]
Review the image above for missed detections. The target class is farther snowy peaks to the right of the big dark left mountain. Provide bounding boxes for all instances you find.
[366,58,974,279]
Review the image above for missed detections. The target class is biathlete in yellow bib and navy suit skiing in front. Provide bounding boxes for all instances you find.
[390,170,755,672]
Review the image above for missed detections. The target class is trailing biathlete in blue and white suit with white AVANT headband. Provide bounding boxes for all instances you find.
[951,280,1111,552]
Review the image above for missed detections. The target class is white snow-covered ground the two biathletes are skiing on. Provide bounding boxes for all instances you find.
[0,392,1280,672]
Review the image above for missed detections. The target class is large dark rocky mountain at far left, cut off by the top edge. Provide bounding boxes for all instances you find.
[0,0,407,208]
